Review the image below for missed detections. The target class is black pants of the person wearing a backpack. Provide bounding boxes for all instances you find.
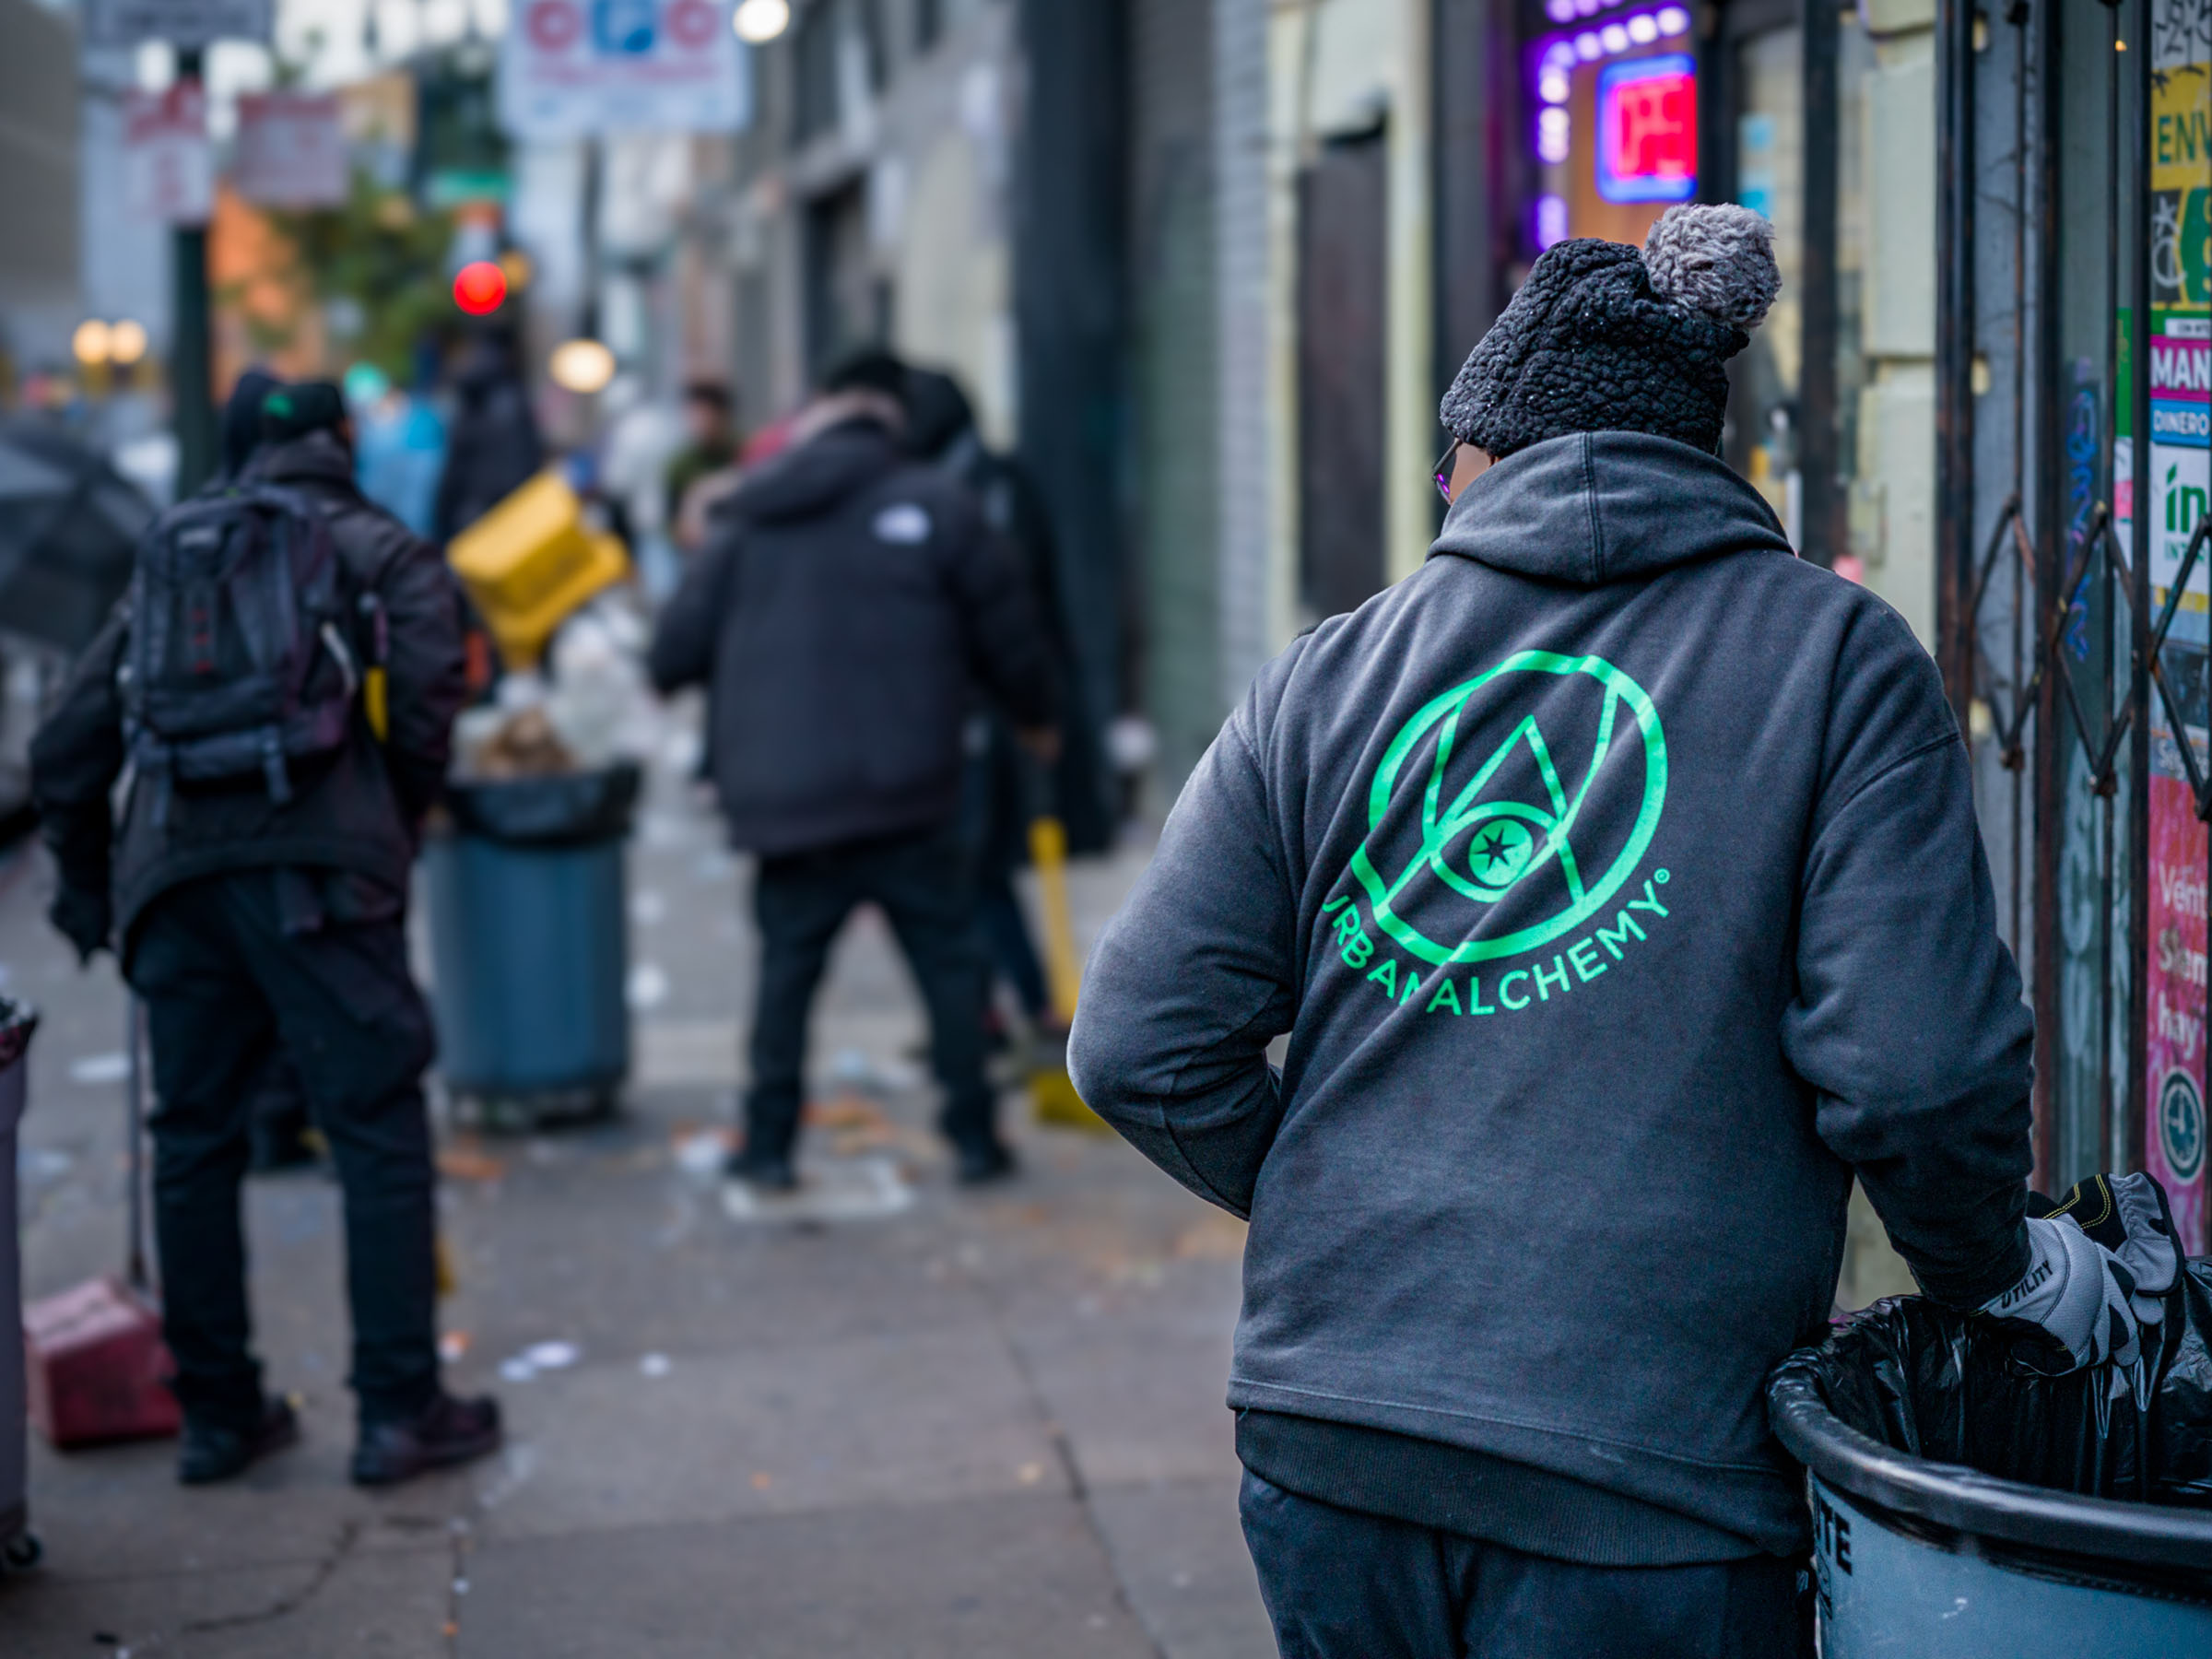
[131,869,438,1425]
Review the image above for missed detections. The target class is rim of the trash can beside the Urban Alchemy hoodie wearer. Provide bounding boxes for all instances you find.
[1768,1349,2212,1572]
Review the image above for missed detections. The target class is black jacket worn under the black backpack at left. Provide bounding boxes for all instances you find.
[31,431,466,951]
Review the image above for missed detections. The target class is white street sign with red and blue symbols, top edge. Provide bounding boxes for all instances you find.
[500,0,752,139]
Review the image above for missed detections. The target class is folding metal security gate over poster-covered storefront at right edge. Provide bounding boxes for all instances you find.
[1936,0,2212,1252]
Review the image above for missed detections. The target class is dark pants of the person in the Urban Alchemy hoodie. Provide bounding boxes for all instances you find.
[1241,1471,1812,1659]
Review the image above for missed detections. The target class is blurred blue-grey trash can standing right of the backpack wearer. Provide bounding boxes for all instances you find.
[427,765,640,1128]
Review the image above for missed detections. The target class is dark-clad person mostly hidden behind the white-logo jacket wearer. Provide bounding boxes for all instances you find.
[905,367,1073,1030]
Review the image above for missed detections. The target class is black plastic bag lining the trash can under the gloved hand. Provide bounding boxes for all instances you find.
[1774,1259,2212,1511]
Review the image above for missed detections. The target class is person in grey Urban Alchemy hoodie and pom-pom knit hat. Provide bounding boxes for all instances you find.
[1068,206,2147,1659]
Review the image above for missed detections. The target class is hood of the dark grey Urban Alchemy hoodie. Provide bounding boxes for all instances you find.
[1429,431,1794,588]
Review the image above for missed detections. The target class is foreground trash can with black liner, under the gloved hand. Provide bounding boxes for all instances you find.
[1768,1261,2212,1659]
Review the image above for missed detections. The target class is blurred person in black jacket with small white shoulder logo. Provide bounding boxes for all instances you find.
[653,354,1053,1190]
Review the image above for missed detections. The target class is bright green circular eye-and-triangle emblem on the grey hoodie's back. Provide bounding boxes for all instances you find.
[1351,651,1665,967]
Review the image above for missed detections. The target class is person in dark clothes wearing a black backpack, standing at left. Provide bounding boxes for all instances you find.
[31,382,500,1487]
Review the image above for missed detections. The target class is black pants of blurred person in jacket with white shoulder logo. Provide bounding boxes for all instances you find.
[746,834,997,1157]
